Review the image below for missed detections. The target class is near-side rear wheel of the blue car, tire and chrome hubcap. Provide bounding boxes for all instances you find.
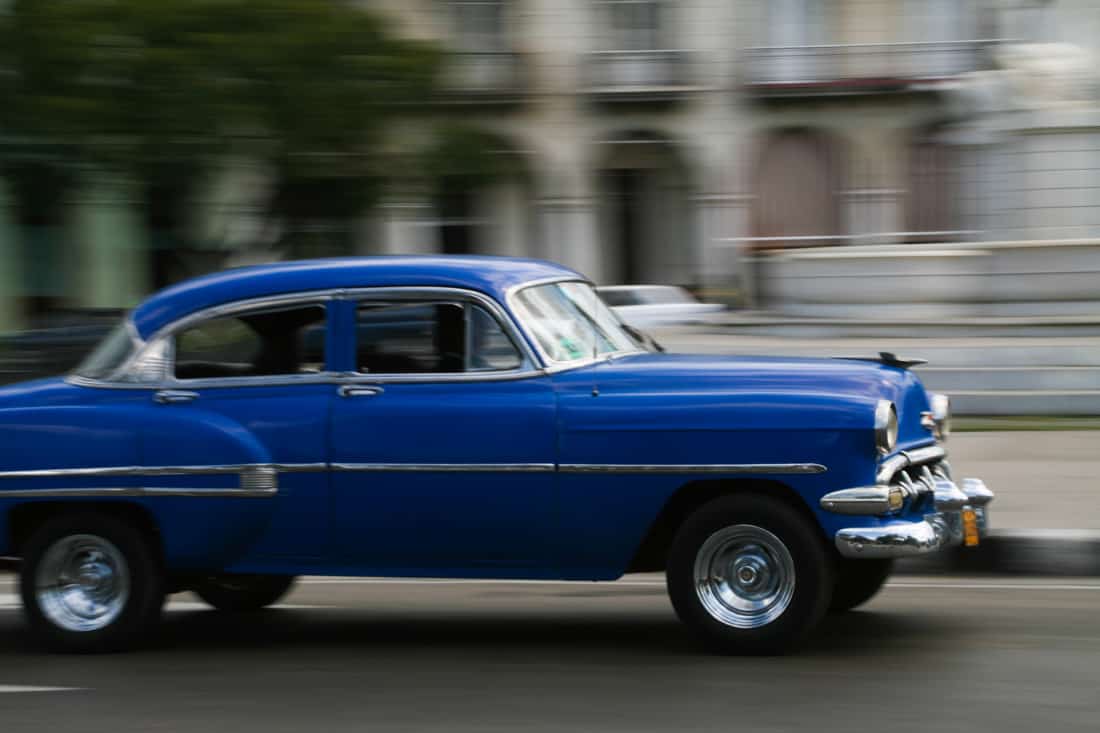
[20,513,164,652]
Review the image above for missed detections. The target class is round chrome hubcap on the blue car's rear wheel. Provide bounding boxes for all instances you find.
[34,535,130,632]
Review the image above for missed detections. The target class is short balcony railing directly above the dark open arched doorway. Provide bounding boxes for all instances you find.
[585,51,693,101]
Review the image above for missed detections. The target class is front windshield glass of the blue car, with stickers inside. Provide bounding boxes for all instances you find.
[514,282,644,363]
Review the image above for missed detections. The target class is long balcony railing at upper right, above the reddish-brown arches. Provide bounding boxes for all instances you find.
[744,41,997,96]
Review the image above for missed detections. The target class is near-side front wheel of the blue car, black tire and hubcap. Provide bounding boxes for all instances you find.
[668,495,833,654]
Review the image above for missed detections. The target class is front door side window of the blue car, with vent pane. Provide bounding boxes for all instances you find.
[355,302,523,374]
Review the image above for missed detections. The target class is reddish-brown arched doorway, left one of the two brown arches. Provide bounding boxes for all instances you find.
[752,129,844,249]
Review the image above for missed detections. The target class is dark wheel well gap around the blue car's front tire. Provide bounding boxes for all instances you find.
[627,479,817,572]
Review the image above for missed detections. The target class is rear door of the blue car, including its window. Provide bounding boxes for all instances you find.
[142,297,333,559]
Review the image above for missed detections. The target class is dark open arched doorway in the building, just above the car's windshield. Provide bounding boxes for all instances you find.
[596,132,697,285]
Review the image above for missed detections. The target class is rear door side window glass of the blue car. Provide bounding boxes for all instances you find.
[174,305,326,380]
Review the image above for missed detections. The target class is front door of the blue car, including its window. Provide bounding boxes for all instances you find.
[330,288,557,577]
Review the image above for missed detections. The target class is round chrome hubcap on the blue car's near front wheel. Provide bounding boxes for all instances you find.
[695,524,794,628]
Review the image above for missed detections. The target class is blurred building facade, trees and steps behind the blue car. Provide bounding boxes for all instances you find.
[0,0,1100,416]
